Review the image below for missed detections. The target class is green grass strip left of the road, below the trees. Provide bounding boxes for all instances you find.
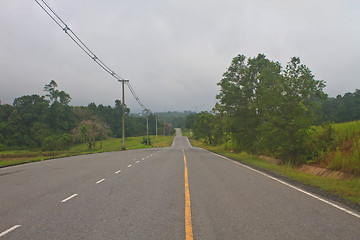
[0,136,174,167]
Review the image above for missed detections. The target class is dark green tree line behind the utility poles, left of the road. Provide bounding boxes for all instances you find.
[0,80,173,150]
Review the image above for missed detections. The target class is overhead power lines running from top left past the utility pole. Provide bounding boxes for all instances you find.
[35,0,149,111]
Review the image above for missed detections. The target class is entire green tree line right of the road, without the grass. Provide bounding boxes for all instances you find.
[185,54,360,164]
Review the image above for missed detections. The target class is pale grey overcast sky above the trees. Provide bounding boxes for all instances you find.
[0,0,360,113]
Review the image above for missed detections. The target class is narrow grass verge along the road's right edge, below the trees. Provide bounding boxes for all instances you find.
[191,139,360,204]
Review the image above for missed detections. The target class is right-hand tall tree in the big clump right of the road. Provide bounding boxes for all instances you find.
[281,57,327,163]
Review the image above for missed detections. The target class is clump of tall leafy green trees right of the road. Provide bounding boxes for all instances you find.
[214,54,326,163]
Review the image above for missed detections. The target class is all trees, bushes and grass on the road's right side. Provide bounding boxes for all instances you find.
[184,54,360,203]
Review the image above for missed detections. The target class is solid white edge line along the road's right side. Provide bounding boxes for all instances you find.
[203,149,360,218]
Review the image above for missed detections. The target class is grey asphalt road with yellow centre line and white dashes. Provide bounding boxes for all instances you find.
[0,131,360,240]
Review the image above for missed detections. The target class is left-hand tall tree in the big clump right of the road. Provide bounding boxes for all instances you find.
[214,54,280,152]
